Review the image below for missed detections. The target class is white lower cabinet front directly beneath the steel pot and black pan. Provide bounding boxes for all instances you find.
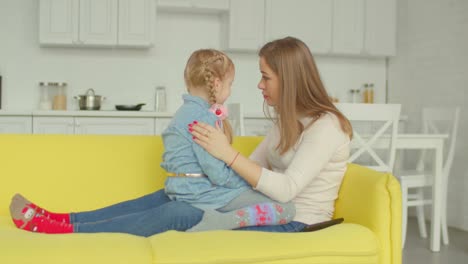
[75,117,154,135]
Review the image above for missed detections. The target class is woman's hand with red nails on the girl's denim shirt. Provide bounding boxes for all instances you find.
[189,121,237,163]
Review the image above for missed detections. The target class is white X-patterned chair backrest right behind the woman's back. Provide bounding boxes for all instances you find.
[336,103,401,172]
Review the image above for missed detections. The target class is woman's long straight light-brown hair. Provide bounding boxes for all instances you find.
[259,37,353,154]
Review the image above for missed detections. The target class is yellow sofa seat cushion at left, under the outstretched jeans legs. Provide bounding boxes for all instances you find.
[0,216,153,264]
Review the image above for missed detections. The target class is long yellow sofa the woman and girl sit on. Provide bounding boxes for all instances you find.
[0,135,401,264]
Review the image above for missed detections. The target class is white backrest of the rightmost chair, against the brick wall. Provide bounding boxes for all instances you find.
[420,107,460,176]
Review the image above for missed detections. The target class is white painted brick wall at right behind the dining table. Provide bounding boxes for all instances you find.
[389,0,468,230]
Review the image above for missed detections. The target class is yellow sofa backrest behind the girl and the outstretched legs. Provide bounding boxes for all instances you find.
[0,134,262,215]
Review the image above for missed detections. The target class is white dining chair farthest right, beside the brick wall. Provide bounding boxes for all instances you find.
[397,107,460,246]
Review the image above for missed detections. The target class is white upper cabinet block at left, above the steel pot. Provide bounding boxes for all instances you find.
[39,0,156,47]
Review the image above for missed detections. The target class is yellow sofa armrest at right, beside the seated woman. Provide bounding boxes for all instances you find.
[335,164,402,264]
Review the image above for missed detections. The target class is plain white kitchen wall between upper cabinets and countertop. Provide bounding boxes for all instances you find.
[0,0,386,113]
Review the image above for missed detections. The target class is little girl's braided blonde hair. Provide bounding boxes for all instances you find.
[184,49,235,143]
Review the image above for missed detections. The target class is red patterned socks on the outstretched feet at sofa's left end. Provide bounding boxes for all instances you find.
[10,207,73,234]
